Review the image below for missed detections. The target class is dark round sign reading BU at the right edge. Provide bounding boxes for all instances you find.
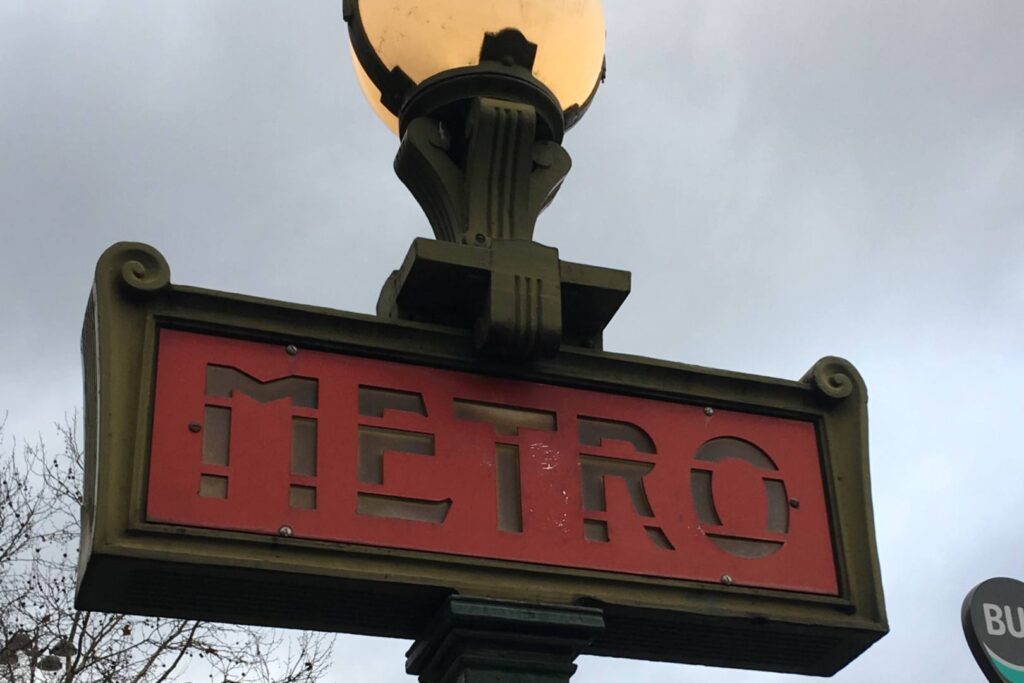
[961,579,1024,683]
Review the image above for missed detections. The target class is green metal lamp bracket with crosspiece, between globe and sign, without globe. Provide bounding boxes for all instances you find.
[364,29,629,358]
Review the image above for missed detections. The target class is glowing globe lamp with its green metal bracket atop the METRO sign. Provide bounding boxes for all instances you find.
[345,0,629,357]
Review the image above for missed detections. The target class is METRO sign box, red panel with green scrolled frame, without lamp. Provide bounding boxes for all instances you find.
[78,244,887,675]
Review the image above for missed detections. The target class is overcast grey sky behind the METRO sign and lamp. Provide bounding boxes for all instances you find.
[0,0,1024,683]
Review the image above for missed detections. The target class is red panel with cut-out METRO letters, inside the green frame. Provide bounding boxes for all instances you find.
[146,330,838,595]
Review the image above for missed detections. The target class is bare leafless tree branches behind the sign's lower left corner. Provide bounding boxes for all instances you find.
[0,420,333,683]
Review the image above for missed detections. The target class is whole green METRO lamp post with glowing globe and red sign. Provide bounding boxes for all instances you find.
[72,5,888,683]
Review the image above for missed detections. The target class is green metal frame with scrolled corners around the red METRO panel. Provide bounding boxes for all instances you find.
[77,243,888,675]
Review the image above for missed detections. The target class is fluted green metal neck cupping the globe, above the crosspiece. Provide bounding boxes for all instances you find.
[394,29,571,245]
